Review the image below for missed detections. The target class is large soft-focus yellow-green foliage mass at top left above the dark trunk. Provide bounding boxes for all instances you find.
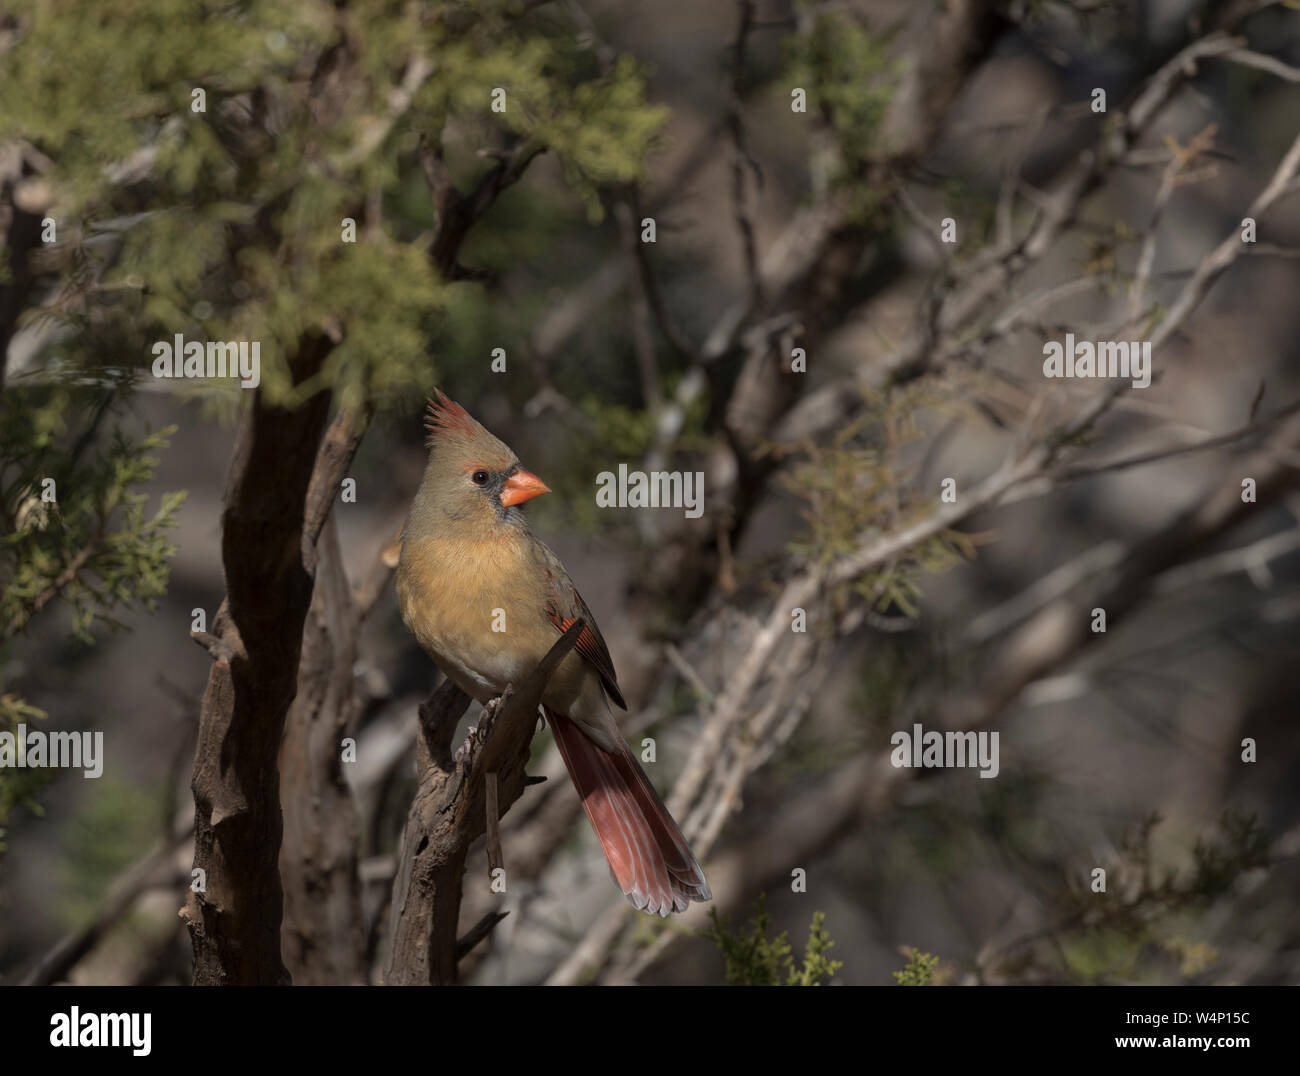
[0,0,666,405]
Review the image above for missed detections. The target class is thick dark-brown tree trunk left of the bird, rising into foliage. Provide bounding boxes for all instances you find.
[183,335,332,985]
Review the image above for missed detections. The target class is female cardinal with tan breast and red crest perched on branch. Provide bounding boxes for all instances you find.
[397,392,712,916]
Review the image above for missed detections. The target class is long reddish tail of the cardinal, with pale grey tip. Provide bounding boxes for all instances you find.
[545,707,712,916]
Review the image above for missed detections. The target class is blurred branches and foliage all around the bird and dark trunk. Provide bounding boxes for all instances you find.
[0,0,1300,984]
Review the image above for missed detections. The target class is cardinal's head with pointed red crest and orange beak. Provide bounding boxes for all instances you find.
[421,391,550,524]
